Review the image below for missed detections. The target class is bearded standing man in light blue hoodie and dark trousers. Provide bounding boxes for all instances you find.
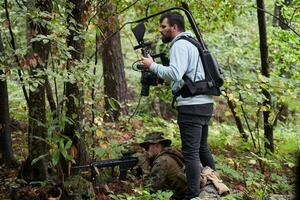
[142,12,215,200]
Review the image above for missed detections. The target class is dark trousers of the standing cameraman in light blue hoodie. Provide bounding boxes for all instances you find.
[177,112,215,200]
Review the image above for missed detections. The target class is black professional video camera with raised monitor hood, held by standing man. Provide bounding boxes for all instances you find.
[132,22,169,96]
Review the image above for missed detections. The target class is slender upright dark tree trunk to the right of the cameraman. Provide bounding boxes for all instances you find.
[256,0,274,152]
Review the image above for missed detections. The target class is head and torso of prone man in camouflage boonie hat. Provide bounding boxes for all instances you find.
[140,132,186,199]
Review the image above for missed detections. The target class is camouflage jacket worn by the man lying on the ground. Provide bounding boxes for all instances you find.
[144,147,187,199]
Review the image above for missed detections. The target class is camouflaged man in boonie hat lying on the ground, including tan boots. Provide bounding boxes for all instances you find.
[139,132,229,200]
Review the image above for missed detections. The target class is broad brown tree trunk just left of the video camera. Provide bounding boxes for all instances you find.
[99,1,127,121]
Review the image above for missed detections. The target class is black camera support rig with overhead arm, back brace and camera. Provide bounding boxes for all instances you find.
[124,7,224,120]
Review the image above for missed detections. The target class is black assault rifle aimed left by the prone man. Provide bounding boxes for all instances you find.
[72,151,138,181]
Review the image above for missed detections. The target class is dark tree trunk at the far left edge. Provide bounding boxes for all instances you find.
[0,32,17,167]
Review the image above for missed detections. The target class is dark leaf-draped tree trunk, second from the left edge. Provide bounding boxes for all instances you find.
[22,0,52,180]
